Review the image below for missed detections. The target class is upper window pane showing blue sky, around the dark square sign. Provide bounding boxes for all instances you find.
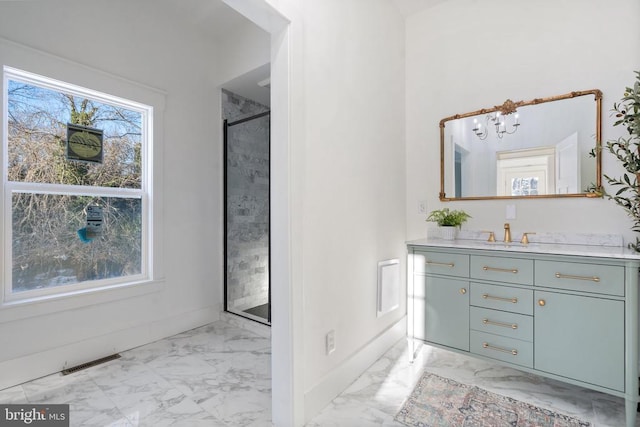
[7,80,142,189]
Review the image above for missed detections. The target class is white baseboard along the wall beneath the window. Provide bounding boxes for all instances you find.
[0,307,220,390]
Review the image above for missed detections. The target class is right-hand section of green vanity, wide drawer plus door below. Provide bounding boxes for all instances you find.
[534,258,624,392]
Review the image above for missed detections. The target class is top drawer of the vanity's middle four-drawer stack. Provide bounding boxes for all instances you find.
[471,255,533,285]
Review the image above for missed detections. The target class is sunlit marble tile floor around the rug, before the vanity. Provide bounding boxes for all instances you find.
[307,340,640,427]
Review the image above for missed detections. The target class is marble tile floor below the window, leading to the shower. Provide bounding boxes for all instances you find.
[0,322,271,427]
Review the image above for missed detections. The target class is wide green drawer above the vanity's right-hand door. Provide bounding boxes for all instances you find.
[535,261,624,296]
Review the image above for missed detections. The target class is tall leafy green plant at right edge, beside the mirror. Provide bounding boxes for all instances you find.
[604,71,640,252]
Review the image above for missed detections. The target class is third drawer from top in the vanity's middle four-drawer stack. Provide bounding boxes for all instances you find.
[469,307,533,341]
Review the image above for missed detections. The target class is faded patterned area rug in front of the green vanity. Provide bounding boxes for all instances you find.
[395,372,591,427]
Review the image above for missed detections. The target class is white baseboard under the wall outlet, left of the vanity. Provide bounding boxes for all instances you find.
[304,316,407,422]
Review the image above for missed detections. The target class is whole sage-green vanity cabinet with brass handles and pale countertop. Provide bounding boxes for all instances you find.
[408,241,640,426]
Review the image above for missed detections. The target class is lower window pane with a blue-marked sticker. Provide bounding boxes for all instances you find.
[12,193,142,292]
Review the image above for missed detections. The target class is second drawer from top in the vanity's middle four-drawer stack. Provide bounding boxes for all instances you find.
[470,283,533,315]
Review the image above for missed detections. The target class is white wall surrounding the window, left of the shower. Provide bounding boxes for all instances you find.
[0,0,222,388]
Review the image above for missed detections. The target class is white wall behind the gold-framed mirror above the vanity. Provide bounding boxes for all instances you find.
[406,0,640,241]
